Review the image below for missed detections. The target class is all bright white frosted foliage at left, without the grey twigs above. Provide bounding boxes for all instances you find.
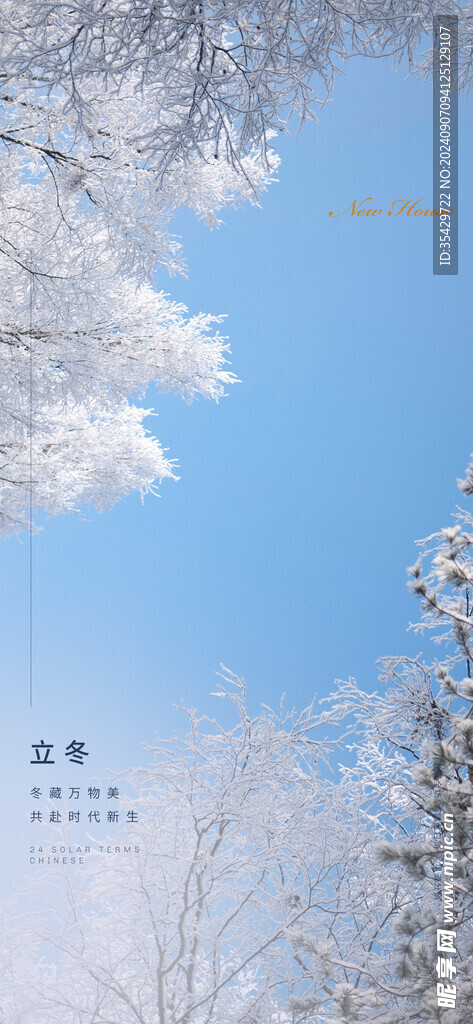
[0,24,277,535]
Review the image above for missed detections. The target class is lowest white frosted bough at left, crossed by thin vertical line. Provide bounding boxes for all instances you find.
[0,402,174,536]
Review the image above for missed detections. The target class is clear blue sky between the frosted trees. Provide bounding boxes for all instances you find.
[0,49,473,897]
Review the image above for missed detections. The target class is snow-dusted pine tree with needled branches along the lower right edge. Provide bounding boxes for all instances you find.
[288,463,473,1024]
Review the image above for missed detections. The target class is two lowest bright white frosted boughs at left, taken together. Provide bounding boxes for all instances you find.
[0,249,233,536]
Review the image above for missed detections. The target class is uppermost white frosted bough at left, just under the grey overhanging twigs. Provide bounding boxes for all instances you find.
[0,80,278,287]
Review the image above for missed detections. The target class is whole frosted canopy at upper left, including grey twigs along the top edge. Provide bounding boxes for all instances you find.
[0,0,472,534]
